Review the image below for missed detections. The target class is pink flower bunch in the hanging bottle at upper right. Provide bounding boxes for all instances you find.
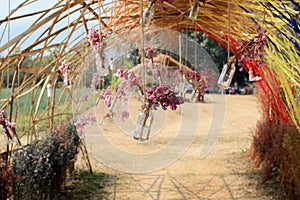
[238,27,268,65]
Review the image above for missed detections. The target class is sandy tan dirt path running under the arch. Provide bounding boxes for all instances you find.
[78,95,282,199]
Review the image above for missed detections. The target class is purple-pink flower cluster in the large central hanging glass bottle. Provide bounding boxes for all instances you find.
[146,84,184,110]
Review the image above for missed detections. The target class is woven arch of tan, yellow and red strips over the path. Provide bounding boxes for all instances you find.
[0,0,300,141]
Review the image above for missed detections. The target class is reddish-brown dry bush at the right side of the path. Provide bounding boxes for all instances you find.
[250,117,300,199]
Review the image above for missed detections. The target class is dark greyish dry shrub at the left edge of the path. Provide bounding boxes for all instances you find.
[12,126,80,200]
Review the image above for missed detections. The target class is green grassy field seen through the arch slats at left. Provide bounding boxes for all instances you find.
[0,88,99,134]
